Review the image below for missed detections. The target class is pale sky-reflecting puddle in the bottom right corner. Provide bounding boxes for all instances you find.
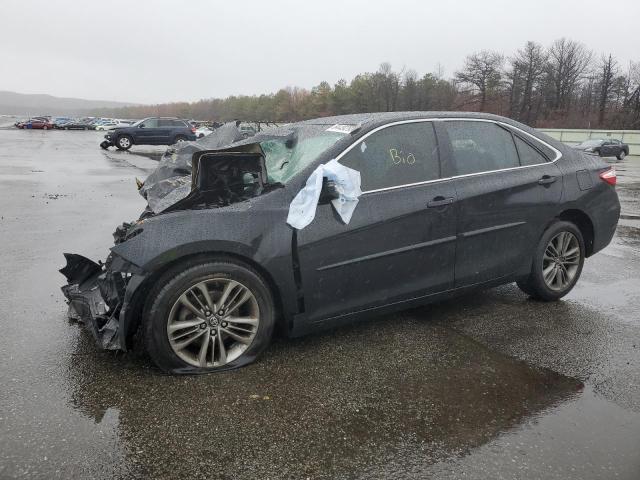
[402,387,640,480]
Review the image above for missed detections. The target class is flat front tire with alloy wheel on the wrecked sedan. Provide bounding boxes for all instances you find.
[142,260,275,373]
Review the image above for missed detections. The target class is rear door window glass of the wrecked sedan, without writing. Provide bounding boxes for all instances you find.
[444,120,520,175]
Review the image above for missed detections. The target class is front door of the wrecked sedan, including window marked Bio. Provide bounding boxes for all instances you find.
[297,122,455,322]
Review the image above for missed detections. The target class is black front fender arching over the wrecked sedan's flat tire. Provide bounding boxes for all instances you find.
[111,201,298,334]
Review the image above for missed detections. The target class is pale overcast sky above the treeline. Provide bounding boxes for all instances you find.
[0,0,640,103]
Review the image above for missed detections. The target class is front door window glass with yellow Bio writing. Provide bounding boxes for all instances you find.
[340,122,440,191]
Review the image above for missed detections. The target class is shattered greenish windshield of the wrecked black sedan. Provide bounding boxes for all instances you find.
[260,124,348,184]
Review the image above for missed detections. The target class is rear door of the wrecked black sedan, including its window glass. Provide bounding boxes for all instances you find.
[443,121,562,287]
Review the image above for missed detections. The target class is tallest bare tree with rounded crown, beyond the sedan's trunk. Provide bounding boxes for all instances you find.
[548,38,592,109]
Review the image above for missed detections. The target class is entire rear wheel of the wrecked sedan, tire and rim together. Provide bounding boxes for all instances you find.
[516,221,585,302]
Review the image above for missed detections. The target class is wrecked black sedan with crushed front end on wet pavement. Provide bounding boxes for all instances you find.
[61,112,620,373]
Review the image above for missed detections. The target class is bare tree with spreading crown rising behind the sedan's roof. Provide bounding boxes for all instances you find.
[456,50,504,112]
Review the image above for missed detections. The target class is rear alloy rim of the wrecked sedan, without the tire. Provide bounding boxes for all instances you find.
[542,231,581,291]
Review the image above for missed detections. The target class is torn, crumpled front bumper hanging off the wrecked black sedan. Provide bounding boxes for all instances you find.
[60,253,144,350]
